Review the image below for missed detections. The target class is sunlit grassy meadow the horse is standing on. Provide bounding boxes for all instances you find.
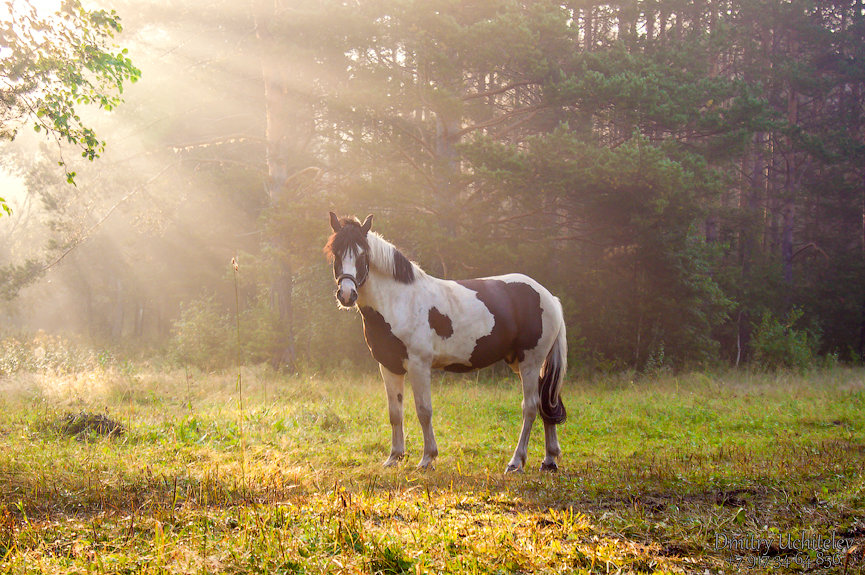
[0,367,865,573]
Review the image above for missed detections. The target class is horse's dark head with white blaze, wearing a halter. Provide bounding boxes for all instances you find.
[324,212,372,307]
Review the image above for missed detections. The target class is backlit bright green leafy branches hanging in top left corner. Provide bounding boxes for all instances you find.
[0,0,141,183]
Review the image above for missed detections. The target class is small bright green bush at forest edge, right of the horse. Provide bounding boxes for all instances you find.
[751,308,819,371]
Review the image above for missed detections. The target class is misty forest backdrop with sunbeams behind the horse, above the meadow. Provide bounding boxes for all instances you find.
[0,0,865,370]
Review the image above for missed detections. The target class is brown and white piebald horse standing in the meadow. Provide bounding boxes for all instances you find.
[324,212,567,472]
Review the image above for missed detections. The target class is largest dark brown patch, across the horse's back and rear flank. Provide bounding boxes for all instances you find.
[445,279,544,372]
